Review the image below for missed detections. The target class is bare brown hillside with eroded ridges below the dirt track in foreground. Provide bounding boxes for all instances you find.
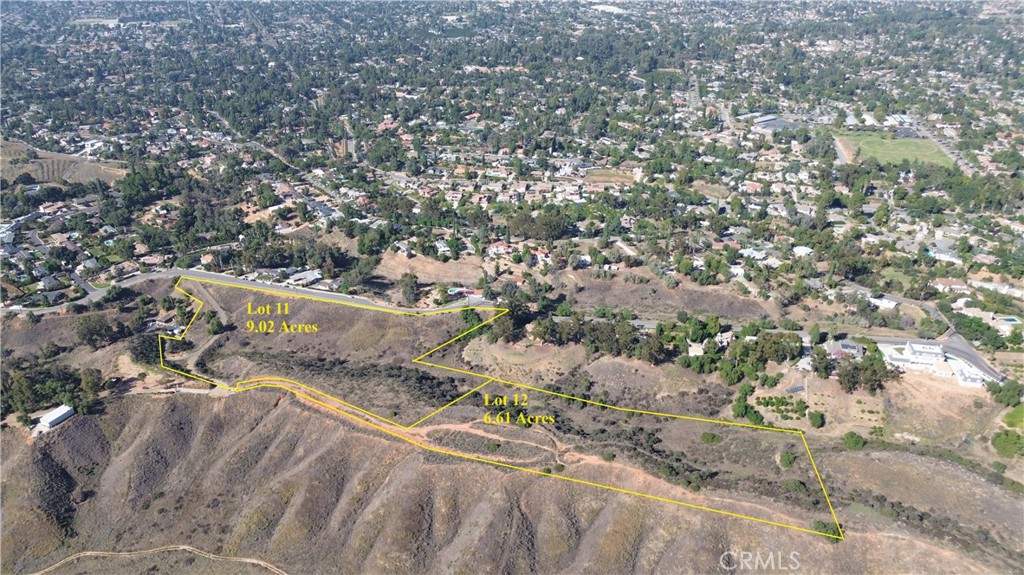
[0,391,1007,573]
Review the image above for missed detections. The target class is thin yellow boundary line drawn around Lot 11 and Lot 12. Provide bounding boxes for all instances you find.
[158,275,846,540]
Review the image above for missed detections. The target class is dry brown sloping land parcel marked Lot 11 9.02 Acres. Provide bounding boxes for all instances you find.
[168,281,482,424]
